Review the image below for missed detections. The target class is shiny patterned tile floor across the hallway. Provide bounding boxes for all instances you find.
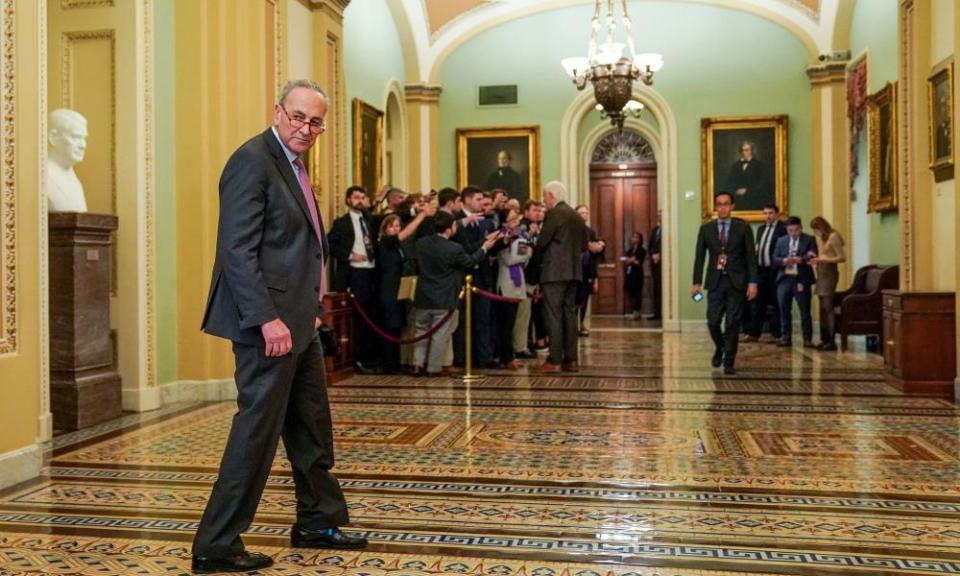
[0,331,960,576]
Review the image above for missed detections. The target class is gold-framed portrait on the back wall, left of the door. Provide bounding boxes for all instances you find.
[457,126,540,205]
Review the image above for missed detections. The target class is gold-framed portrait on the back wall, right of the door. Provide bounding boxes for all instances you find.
[700,114,790,222]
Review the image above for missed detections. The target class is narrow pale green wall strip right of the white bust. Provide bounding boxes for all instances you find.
[154,2,177,384]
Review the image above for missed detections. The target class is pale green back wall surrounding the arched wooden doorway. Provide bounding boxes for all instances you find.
[438,1,812,320]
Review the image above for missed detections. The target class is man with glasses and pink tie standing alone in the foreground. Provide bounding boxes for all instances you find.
[193,80,366,573]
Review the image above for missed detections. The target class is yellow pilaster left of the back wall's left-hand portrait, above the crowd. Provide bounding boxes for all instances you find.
[405,84,453,192]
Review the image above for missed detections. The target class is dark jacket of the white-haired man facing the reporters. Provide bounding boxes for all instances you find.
[532,202,587,284]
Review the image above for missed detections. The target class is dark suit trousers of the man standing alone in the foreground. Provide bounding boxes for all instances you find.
[193,336,349,557]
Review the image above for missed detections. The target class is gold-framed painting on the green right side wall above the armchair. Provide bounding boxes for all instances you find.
[867,82,900,212]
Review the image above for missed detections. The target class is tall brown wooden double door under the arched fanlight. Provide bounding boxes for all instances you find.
[590,162,657,315]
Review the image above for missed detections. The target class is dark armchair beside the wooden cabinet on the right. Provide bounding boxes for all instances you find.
[833,265,900,350]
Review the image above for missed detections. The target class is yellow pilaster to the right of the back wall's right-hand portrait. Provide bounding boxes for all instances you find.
[808,60,853,286]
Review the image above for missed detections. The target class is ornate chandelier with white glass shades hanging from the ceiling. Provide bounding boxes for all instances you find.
[560,0,663,131]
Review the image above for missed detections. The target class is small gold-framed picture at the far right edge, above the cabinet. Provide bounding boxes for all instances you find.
[927,58,954,182]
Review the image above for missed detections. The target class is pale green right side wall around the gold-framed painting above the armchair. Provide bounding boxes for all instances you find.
[850,0,900,264]
